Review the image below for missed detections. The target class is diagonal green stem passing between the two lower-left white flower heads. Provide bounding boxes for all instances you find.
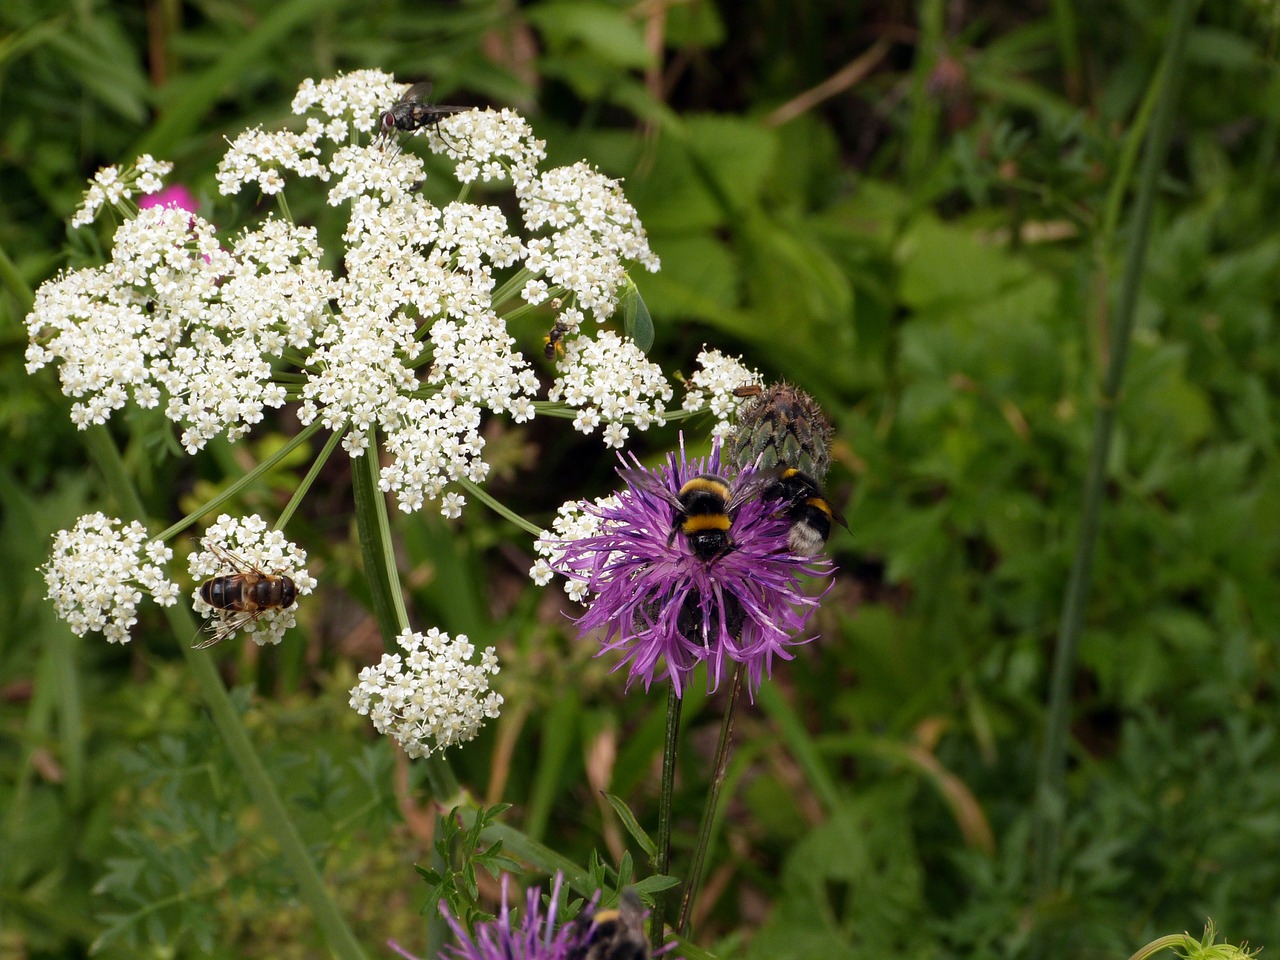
[86,426,365,960]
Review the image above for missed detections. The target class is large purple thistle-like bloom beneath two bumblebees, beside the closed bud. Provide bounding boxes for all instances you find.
[553,440,831,696]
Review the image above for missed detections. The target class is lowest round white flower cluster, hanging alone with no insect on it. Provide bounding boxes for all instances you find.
[351,627,502,758]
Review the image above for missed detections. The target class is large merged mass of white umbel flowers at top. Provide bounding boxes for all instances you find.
[27,70,672,516]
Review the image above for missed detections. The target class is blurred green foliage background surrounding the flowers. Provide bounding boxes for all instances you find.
[0,0,1280,960]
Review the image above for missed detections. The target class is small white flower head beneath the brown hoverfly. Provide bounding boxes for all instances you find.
[187,513,316,646]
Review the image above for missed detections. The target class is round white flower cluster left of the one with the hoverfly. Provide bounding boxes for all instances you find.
[44,513,178,644]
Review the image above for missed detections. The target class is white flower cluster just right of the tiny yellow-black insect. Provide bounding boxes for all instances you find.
[548,330,672,448]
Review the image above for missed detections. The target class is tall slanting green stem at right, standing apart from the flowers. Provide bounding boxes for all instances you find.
[1032,0,1194,911]
